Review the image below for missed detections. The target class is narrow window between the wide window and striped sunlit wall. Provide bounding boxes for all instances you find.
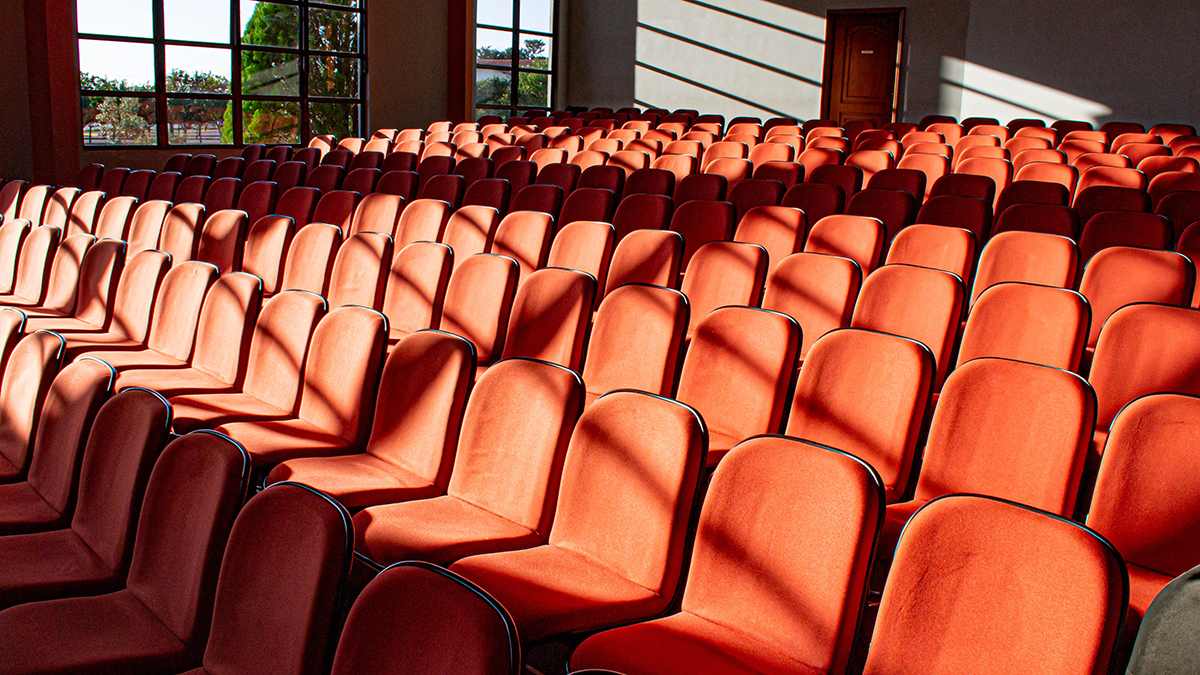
[475,0,557,118]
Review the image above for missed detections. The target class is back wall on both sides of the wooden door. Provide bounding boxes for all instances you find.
[564,0,1200,126]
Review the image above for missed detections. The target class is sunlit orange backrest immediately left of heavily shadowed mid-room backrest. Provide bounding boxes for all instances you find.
[440,253,520,365]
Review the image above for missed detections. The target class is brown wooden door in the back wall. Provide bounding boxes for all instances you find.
[821,10,904,127]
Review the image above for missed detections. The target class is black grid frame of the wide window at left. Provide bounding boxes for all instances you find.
[73,0,368,150]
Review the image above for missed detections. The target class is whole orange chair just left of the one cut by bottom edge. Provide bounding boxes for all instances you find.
[451,392,706,643]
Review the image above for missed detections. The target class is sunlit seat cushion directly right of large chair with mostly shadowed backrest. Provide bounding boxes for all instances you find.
[354,495,546,566]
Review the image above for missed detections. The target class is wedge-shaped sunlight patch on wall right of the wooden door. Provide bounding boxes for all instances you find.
[940,56,1112,124]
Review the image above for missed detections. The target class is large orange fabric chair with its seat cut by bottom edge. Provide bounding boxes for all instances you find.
[571,437,883,675]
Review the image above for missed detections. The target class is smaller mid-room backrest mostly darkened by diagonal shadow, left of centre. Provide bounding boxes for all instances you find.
[500,268,596,371]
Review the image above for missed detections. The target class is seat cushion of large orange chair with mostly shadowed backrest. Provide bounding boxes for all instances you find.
[266,453,443,509]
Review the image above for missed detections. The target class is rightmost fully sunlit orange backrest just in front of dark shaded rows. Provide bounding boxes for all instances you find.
[1079,246,1196,347]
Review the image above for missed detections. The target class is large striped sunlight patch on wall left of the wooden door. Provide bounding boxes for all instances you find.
[634,0,826,119]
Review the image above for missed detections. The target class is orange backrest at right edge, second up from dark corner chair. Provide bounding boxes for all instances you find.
[1088,304,1200,427]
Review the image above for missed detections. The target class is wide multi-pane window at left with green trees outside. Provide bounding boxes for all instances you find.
[76,0,366,147]
